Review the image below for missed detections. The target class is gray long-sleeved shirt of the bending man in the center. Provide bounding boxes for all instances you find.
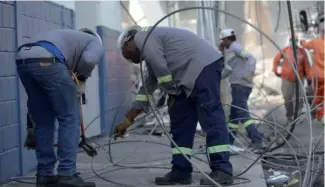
[133,27,222,110]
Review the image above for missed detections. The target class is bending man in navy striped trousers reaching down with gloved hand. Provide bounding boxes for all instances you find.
[115,27,233,185]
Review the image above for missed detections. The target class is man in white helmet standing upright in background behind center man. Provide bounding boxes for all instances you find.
[220,29,265,149]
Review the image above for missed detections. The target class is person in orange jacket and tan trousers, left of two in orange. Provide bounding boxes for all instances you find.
[273,37,311,122]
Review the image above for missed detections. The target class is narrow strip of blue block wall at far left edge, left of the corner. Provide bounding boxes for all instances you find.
[0,1,21,184]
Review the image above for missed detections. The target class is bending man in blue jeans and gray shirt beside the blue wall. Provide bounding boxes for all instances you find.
[16,29,104,187]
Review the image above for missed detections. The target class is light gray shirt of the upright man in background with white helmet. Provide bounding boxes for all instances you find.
[225,42,256,88]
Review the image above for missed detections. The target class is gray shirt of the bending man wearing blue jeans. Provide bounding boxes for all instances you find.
[18,29,104,78]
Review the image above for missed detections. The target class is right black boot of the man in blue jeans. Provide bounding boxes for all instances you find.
[57,174,96,187]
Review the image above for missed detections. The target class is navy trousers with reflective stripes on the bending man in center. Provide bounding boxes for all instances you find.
[169,59,232,176]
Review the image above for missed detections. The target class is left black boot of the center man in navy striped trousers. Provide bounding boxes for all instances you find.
[155,171,192,185]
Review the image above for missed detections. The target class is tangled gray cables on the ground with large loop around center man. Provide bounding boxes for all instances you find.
[12,4,324,187]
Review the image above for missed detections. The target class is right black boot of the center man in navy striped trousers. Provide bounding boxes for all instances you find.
[200,171,234,185]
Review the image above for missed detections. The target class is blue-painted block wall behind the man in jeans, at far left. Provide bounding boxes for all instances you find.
[0,1,74,184]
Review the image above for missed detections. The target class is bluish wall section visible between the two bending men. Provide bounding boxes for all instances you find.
[97,26,132,136]
